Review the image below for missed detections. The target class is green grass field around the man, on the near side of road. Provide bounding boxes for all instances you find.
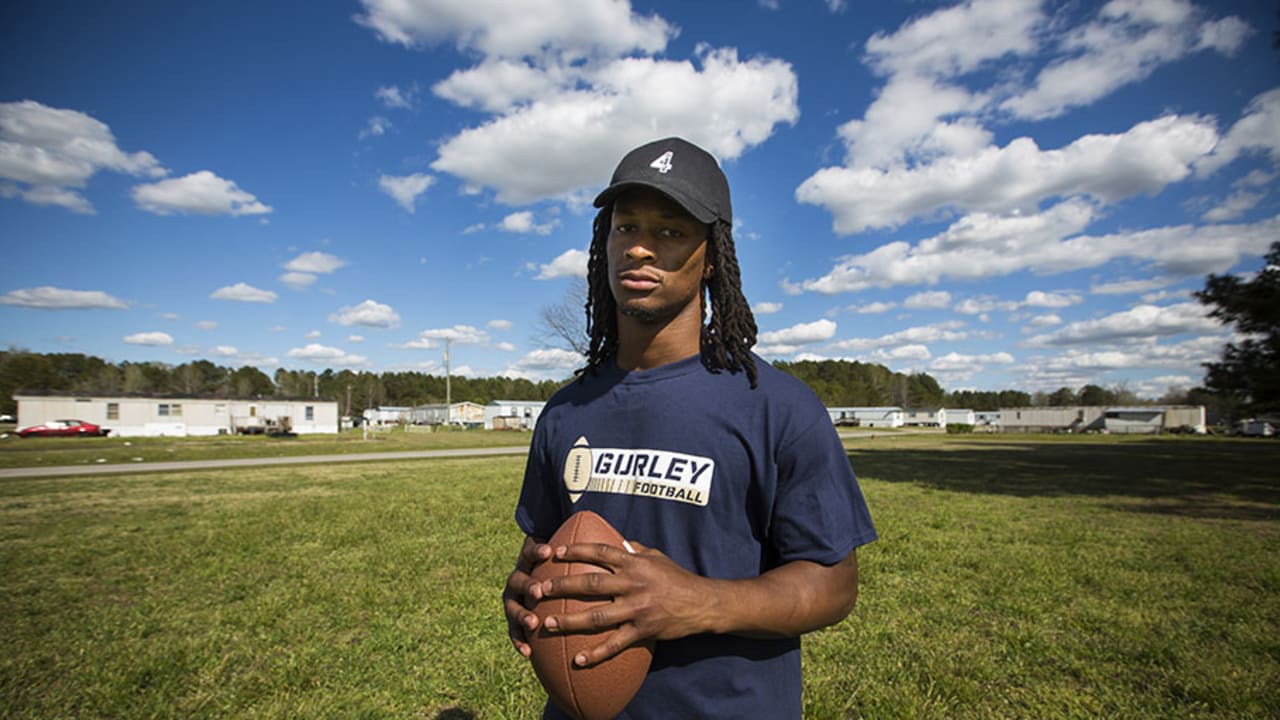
[0,436,1280,720]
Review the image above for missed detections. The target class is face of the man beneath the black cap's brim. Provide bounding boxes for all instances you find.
[608,188,709,327]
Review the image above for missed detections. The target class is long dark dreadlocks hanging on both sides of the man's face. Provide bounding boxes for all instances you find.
[577,202,756,388]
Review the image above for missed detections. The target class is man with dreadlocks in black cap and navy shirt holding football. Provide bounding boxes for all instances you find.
[503,138,876,720]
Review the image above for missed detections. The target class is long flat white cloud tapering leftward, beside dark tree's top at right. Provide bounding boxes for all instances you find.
[1027,302,1222,347]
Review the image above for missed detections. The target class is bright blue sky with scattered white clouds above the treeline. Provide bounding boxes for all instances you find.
[0,0,1280,397]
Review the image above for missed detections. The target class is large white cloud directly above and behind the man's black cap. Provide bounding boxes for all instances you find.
[431,45,799,204]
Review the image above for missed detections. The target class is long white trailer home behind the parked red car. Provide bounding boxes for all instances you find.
[14,392,338,437]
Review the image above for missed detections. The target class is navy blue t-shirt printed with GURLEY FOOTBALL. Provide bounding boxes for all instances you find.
[516,356,876,720]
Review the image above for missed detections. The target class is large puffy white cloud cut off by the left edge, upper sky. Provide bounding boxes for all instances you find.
[0,100,168,214]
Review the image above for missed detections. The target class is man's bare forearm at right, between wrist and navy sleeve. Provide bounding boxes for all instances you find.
[705,551,858,637]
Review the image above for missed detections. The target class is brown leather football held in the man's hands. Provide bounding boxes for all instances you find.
[529,510,653,720]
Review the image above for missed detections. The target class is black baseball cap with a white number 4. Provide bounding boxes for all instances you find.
[595,137,733,224]
